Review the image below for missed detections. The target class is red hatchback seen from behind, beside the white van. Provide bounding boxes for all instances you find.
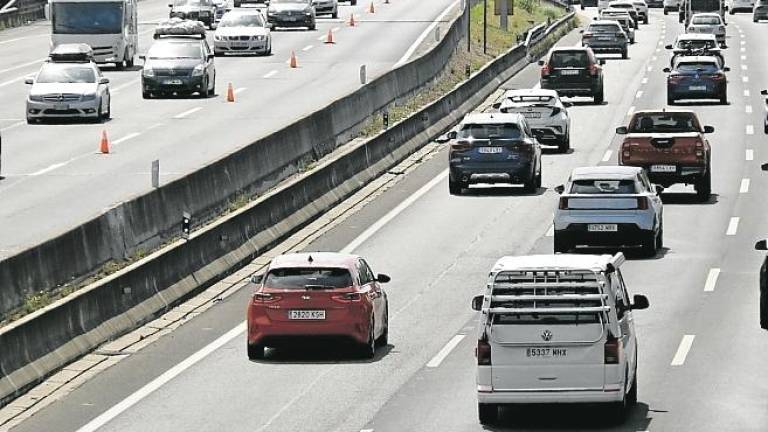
[248,252,390,360]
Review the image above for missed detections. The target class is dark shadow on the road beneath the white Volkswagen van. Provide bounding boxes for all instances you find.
[484,402,653,432]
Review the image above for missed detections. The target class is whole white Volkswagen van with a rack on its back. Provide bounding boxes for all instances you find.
[472,253,648,424]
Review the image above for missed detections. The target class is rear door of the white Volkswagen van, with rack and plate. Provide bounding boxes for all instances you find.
[488,271,608,391]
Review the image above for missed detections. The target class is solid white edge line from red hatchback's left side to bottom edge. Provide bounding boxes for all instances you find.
[77,322,246,432]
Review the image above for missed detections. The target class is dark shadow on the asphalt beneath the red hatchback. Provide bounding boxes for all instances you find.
[251,341,396,364]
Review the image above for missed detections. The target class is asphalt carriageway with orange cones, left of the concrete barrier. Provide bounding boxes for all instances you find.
[0,0,458,259]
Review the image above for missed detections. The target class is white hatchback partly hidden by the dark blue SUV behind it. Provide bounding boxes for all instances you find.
[498,89,571,153]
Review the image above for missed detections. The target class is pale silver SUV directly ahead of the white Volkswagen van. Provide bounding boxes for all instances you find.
[554,166,664,257]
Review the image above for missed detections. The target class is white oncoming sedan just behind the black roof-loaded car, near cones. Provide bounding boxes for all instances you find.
[213,8,272,56]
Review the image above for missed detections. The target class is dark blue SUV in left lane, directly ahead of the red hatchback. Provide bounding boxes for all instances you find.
[437,113,541,195]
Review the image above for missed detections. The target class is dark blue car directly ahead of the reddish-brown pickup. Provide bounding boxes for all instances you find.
[664,56,730,105]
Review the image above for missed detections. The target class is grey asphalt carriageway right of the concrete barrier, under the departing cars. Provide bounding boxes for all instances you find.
[6,3,768,432]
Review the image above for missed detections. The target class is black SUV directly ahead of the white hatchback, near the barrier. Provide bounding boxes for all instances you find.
[539,47,605,104]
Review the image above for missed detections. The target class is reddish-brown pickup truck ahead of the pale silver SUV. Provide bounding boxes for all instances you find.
[616,110,715,201]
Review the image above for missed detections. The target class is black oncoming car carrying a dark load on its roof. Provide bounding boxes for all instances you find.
[141,21,216,99]
